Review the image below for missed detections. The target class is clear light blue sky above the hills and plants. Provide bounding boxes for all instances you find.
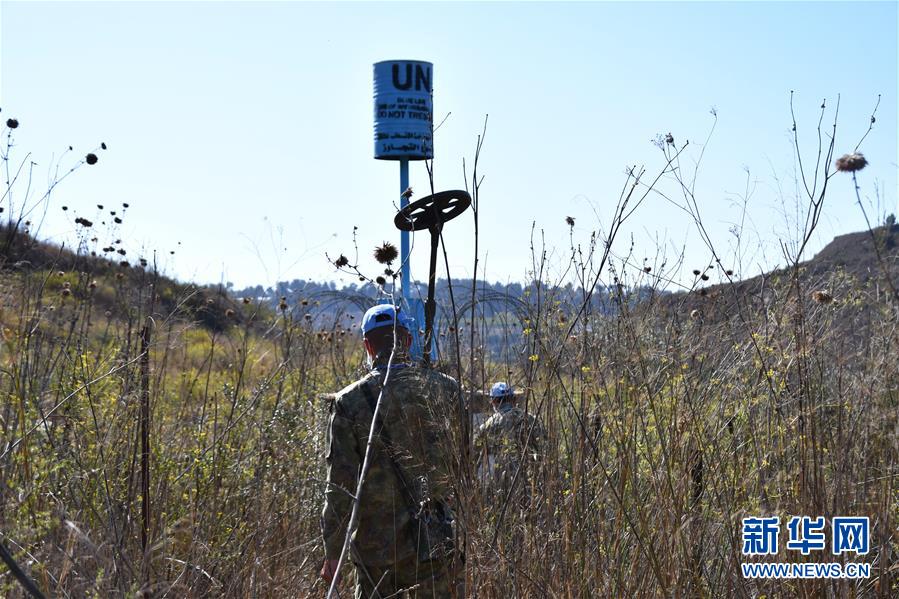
[0,2,899,286]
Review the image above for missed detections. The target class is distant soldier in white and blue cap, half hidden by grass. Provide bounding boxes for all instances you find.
[475,382,546,490]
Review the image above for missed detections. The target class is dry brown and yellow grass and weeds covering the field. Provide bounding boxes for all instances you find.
[0,104,899,598]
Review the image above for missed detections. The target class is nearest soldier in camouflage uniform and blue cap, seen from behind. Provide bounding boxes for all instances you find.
[321,305,463,599]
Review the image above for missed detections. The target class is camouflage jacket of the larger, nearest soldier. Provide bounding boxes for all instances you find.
[322,366,461,566]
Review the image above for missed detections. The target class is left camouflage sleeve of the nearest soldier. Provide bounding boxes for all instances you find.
[322,404,361,560]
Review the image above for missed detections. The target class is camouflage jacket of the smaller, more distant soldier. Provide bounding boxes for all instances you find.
[474,406,546,480]
